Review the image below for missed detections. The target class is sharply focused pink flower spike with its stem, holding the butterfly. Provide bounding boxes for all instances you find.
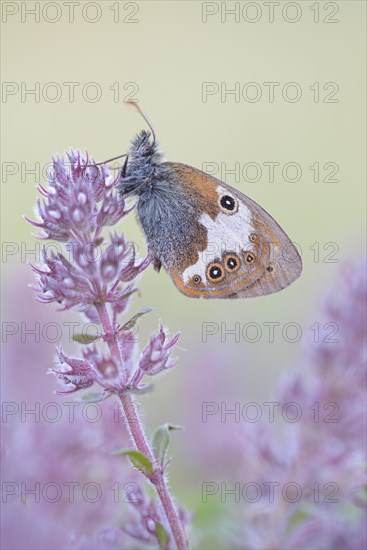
[23,152,186,548]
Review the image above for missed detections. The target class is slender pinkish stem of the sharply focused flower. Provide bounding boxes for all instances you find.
[96,304,188,550]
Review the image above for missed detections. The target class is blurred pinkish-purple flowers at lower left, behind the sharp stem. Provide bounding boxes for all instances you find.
[1,294,131,550]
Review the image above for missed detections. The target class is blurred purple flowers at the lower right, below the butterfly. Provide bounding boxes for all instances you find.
[237,265,367,550]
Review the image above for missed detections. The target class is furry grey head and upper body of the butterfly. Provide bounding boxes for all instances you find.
[119,130,162,197]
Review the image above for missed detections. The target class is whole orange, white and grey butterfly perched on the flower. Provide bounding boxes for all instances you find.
[103,103,302,298]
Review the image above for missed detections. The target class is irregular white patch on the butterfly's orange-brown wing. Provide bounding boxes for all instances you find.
[182,185,255,284]
